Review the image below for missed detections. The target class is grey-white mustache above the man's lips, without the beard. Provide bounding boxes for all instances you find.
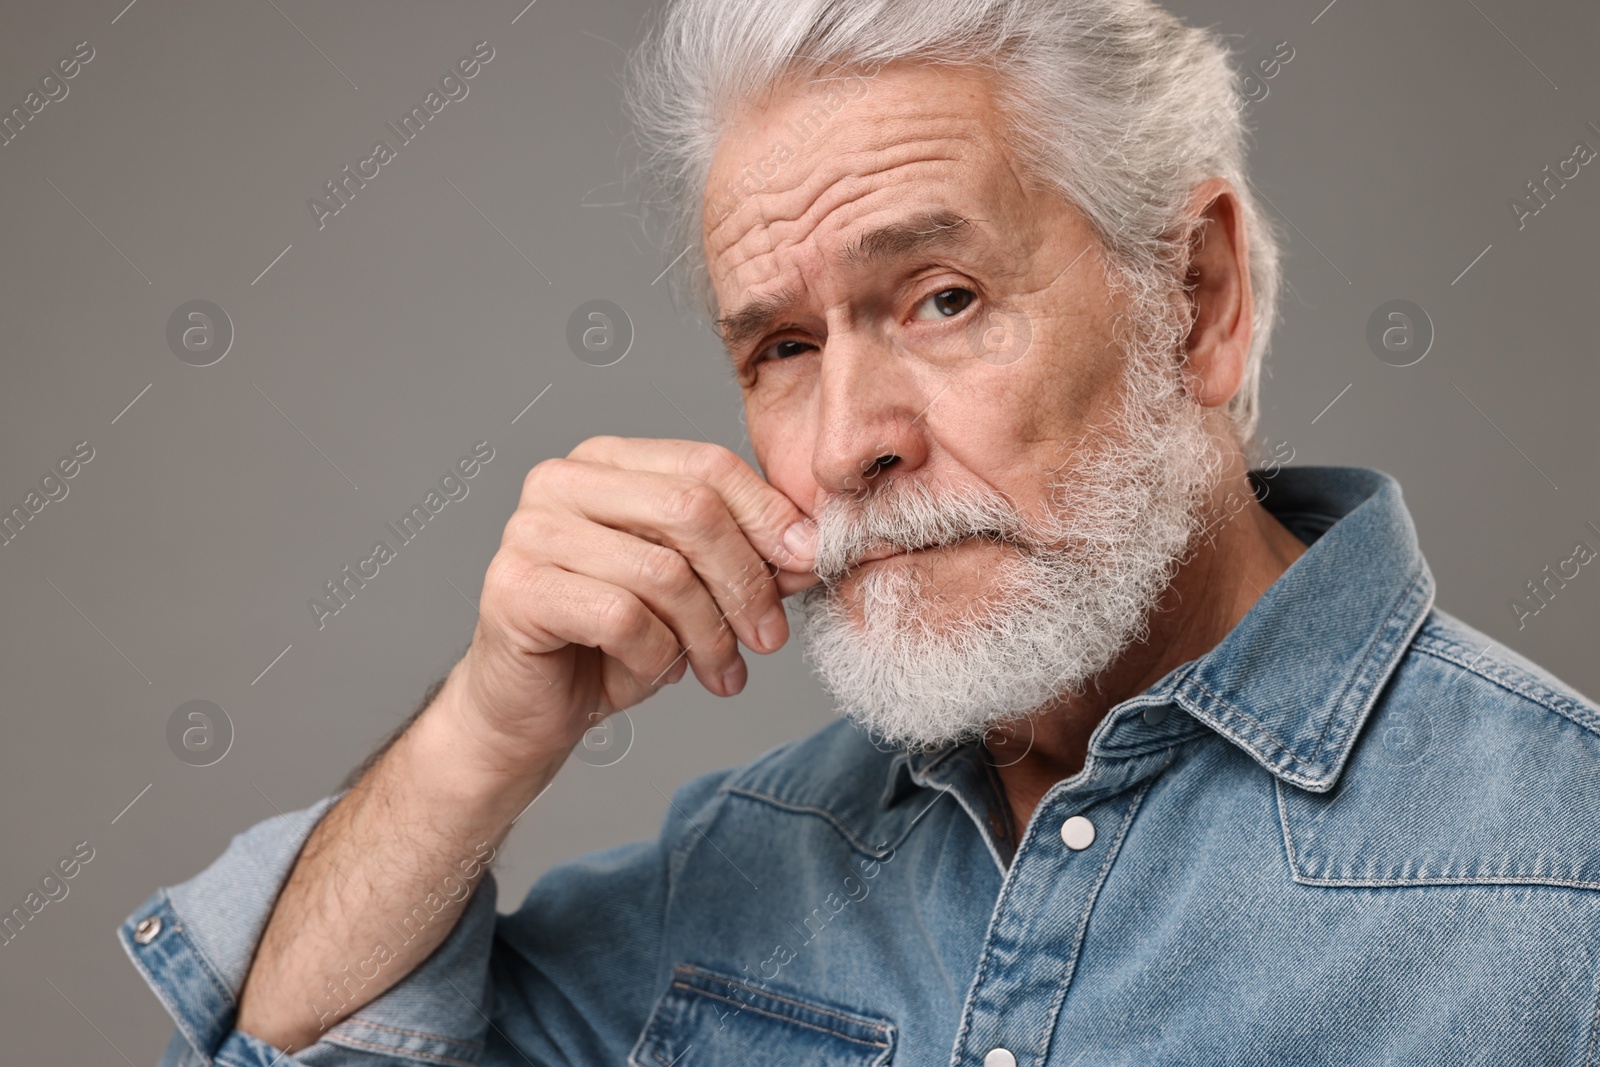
[813,478,1037,585]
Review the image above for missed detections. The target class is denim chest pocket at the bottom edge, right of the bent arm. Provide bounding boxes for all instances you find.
[627,963,894,1067]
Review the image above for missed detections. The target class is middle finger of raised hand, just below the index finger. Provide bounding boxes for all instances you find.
[526,459,789,653]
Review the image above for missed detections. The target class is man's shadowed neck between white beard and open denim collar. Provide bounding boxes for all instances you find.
[997,453,1306,840]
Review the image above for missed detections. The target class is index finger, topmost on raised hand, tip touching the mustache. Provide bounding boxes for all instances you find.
[570,437,814,571]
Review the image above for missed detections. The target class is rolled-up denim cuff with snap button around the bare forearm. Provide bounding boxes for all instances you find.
[117,797,496,1067]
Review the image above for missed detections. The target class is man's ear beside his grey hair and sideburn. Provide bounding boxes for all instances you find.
[1184,178,1254,408]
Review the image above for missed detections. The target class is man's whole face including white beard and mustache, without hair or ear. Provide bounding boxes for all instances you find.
[704,58,1210,742]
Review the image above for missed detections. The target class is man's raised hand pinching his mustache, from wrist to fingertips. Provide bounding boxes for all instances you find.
[444,437,816,780]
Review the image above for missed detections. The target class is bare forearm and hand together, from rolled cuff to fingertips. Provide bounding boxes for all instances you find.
[237,437,818,1048]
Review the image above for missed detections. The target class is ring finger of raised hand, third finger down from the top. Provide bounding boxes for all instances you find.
[518,520,739,694]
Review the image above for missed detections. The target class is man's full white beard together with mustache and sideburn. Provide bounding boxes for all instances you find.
[798,315,1222,747]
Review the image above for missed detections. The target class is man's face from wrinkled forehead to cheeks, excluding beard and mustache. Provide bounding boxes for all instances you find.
[706,67,1123,607]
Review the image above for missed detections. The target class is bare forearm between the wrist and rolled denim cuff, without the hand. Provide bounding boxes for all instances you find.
[235,664,566,1048]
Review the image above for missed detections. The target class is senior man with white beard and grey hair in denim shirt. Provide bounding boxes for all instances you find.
[122,0,1600,1067]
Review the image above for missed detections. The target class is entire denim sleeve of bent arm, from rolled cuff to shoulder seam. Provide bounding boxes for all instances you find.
[118,771,726,1067]
